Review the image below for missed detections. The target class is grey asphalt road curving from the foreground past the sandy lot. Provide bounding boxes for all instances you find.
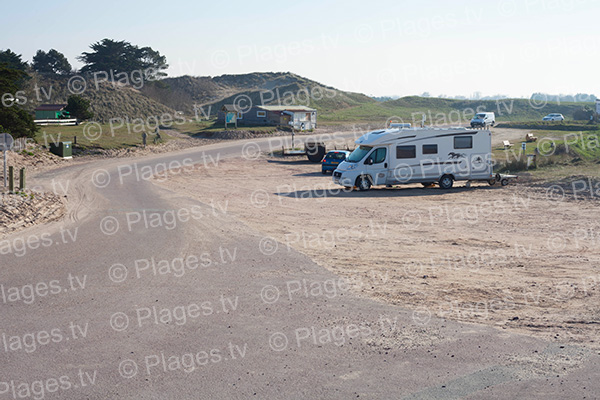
[0,136,600,399]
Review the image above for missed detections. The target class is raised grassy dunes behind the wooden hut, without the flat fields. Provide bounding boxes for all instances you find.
[25,72,375,123]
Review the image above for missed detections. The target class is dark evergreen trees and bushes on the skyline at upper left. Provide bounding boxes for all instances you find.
[0,39,169,137]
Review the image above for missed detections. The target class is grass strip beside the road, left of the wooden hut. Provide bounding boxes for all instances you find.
[36,123,171,150]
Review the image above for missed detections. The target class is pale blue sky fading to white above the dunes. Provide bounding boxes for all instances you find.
[0,0,600,96]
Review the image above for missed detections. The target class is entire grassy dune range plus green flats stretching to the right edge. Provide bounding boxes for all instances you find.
[21,72,592,124]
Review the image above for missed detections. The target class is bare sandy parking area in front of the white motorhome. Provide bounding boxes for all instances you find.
[157,131,600,347]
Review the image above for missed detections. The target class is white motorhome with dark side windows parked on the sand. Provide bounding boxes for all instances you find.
[333,128,494,190]
